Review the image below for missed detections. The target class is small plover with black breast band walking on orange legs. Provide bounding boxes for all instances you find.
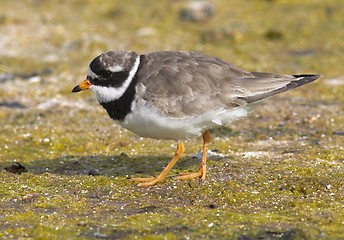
[72,50,320,187]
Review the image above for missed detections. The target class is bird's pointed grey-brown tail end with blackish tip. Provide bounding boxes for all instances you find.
[238,72,321,103]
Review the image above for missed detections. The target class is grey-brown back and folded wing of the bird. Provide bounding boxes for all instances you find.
[138,52,319,118]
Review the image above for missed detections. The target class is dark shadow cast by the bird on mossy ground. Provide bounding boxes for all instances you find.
[0,153,199,177]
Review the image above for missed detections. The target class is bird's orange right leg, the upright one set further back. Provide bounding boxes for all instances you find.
[177,130,210,181]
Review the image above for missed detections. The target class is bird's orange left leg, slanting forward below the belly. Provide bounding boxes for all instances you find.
[131,141,185,187]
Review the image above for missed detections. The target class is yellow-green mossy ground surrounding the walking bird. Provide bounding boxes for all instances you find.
[0,0,344,239]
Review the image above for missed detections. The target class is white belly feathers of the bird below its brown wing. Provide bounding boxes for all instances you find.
[119,101,250,140]
